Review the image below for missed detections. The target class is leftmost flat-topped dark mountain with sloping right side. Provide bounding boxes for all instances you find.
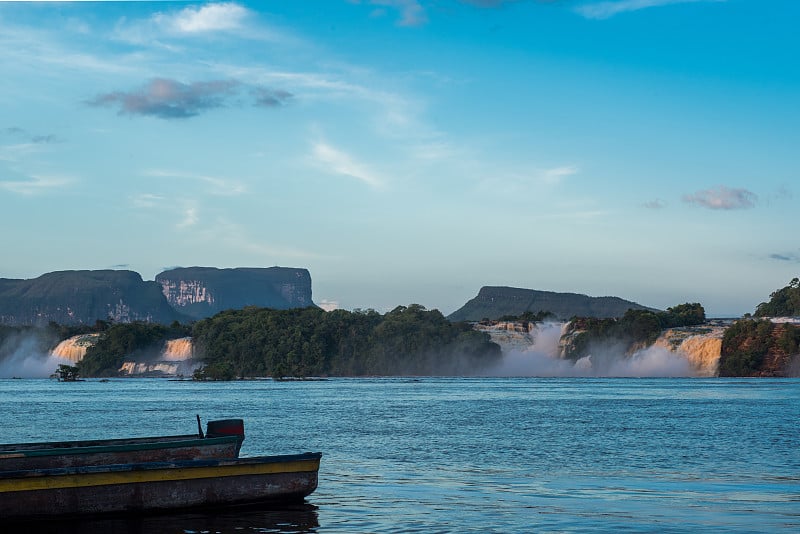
[0,270,178,325]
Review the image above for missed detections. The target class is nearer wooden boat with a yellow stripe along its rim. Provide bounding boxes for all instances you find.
[0,453,322,520]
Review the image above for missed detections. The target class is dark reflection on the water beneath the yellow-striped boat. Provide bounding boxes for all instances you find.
[7,504,319,534]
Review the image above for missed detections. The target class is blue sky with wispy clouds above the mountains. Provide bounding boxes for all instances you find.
[0,0,800,317]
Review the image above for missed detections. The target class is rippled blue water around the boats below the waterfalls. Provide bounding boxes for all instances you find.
[0,378,800,533]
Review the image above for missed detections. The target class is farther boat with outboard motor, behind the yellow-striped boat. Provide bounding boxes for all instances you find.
[0,417,244,471]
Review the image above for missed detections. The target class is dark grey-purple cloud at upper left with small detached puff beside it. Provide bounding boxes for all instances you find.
[86,78,293,119]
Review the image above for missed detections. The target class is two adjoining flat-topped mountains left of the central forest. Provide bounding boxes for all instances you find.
[0,267,314,325]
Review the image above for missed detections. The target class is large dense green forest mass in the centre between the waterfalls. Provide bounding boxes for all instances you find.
[193,304,500,380]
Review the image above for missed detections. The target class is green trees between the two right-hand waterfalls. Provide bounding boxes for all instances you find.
[566,302,706,360]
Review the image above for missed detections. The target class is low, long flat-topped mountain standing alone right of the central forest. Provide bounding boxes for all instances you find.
[447,286,653,321]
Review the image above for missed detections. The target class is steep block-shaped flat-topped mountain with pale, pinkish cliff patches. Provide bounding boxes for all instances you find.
[156,267,314,319]
